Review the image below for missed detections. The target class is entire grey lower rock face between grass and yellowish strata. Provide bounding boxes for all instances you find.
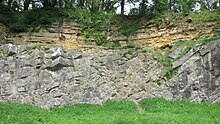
[0,41,220,108]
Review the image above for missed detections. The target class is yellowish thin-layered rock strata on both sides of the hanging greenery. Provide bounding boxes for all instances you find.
[2,19,215,48]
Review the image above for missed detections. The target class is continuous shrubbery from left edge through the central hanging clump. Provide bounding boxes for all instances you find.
[0,6,120,47]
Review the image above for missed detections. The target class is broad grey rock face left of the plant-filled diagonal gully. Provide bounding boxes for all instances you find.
[0,44,171,108]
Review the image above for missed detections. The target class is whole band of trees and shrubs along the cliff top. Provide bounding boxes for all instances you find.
[0,0,220,46]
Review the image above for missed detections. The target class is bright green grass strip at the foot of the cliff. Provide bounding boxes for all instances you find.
[0,99,220,124]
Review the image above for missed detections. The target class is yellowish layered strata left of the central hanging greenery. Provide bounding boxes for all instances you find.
[6,21,83,44]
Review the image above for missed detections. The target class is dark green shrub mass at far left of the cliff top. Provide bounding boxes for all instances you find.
[0,5,66,32]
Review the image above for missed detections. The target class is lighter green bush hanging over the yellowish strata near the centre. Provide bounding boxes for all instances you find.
[65,9,120,47]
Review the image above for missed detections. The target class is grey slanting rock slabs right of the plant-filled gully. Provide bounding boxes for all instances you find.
[167,41,220,103]
